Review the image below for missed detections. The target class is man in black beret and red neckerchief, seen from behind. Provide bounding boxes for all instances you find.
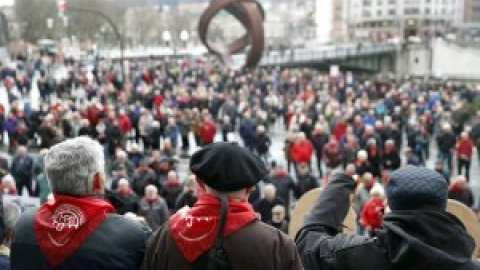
[142,143,302,270]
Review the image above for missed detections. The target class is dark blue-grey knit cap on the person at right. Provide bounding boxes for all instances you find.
[386,166,448,211]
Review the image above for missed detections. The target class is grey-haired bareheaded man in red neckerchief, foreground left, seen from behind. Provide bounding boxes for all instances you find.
[11,137,150,270]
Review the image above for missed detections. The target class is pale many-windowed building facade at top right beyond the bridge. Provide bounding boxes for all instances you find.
[346,0,465,41]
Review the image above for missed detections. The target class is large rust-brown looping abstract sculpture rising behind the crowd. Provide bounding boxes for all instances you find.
[198,0,265,68]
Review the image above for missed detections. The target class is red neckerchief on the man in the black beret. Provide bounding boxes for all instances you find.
[168,195,257,263]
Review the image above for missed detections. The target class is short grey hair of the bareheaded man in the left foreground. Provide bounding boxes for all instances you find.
[45,137,105,197]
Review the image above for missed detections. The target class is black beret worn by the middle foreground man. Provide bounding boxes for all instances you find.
[190,142,268,192]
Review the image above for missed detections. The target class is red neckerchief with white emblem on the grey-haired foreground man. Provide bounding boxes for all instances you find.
[35,196,115,267]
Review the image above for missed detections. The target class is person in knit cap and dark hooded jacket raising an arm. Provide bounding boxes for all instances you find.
[295,166,480,270]
